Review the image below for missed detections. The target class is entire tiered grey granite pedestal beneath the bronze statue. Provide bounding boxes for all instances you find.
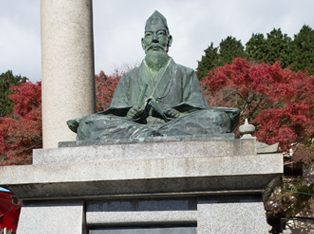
[0,137,283,234]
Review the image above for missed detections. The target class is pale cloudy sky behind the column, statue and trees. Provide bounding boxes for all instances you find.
[0,0,314,82]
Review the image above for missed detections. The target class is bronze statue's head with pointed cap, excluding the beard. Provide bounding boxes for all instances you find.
[142,11,172,54]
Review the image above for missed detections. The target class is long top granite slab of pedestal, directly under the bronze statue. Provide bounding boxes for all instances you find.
[33,137,256,164]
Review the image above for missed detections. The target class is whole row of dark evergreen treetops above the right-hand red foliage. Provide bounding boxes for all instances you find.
[196,25,314,81]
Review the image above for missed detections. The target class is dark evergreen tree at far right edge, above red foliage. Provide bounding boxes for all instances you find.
[292,25,314,75]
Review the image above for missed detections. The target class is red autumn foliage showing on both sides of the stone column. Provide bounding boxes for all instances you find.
[0,70,123,165]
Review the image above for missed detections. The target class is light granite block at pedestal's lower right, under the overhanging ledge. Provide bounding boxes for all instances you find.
[197,196,268,234]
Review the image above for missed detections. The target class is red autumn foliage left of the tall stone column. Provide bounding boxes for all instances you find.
[0,81,42,165]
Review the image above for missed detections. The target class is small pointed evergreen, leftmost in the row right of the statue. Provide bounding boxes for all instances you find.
[196,42,220,80]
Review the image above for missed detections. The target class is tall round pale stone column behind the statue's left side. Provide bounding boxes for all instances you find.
[40,0,95,148]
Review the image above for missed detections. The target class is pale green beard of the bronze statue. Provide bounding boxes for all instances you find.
[145,46,169,71]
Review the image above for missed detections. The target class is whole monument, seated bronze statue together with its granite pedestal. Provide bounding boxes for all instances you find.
[0,8,283,234]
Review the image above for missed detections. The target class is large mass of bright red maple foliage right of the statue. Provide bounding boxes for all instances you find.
[202,58,314,155]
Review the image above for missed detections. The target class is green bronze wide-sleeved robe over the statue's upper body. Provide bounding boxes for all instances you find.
[100,58,208,119]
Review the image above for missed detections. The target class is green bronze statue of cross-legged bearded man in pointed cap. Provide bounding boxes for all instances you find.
[67,11,239,140]
